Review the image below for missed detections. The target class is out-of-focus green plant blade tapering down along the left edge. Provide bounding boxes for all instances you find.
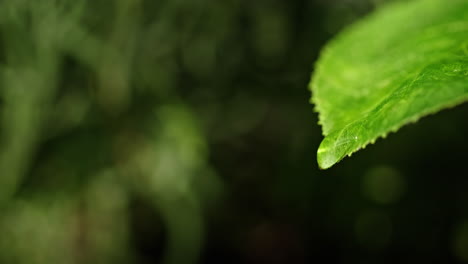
[0,1,77,203]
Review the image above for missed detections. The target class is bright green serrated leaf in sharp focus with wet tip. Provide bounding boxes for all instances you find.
[310,0,468,169]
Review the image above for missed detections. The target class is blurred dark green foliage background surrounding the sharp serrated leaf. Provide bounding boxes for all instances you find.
[0,0,468,264]
